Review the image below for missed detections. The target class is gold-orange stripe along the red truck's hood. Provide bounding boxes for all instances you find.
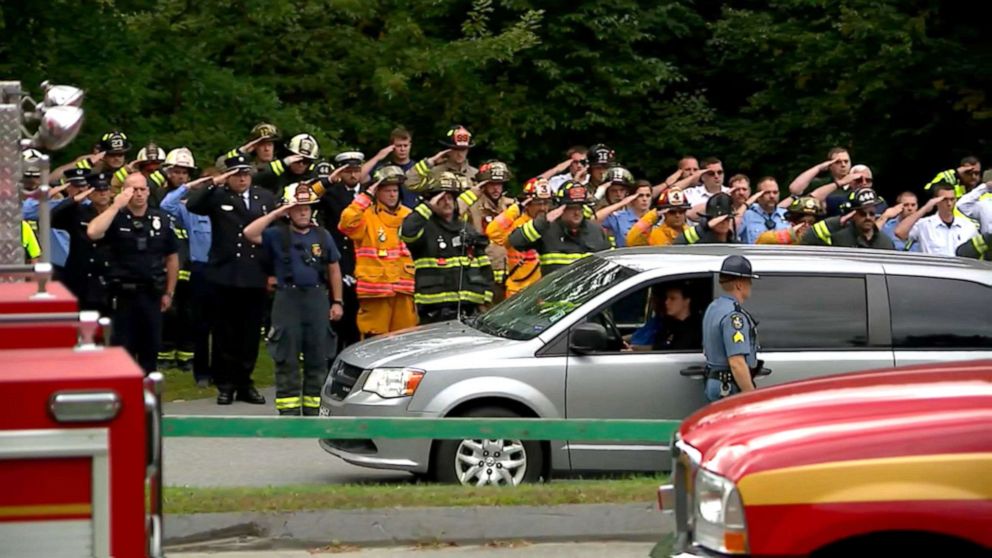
[737,452,992,506]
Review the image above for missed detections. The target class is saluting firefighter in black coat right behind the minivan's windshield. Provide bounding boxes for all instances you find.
[510,180,610,276]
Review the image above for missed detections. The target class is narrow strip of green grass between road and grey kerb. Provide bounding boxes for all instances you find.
[163,475,667,514]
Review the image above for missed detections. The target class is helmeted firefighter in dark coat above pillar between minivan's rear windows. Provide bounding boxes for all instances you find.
[799,188,895,250]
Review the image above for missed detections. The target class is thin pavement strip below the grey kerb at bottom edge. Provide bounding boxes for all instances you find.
[169,542,654,558]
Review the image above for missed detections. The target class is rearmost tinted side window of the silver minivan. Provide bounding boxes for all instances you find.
[886,275,992,349]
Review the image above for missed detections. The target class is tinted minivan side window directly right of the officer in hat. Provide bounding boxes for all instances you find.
[744,275,868,351]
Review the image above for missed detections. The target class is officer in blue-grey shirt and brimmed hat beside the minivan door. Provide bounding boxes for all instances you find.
[703,256,761,401]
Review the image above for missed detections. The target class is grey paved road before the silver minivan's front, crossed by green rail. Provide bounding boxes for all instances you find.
[163,388,413,486]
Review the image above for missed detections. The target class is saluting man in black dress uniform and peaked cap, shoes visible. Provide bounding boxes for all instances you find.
[186,155,276,405]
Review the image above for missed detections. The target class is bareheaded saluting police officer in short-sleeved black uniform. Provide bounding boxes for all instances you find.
[86,174,179,374]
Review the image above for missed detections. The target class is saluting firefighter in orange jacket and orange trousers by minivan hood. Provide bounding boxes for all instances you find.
[338,165,417,339]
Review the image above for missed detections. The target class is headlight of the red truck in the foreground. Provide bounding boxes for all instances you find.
[693,469,748,554]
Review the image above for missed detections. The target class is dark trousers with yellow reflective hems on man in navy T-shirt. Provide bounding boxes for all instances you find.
[267,287,335,415]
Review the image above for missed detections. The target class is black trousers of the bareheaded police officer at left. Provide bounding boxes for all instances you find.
[111,288,162,374]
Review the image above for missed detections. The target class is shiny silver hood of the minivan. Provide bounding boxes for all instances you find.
[341,321,520,368]
